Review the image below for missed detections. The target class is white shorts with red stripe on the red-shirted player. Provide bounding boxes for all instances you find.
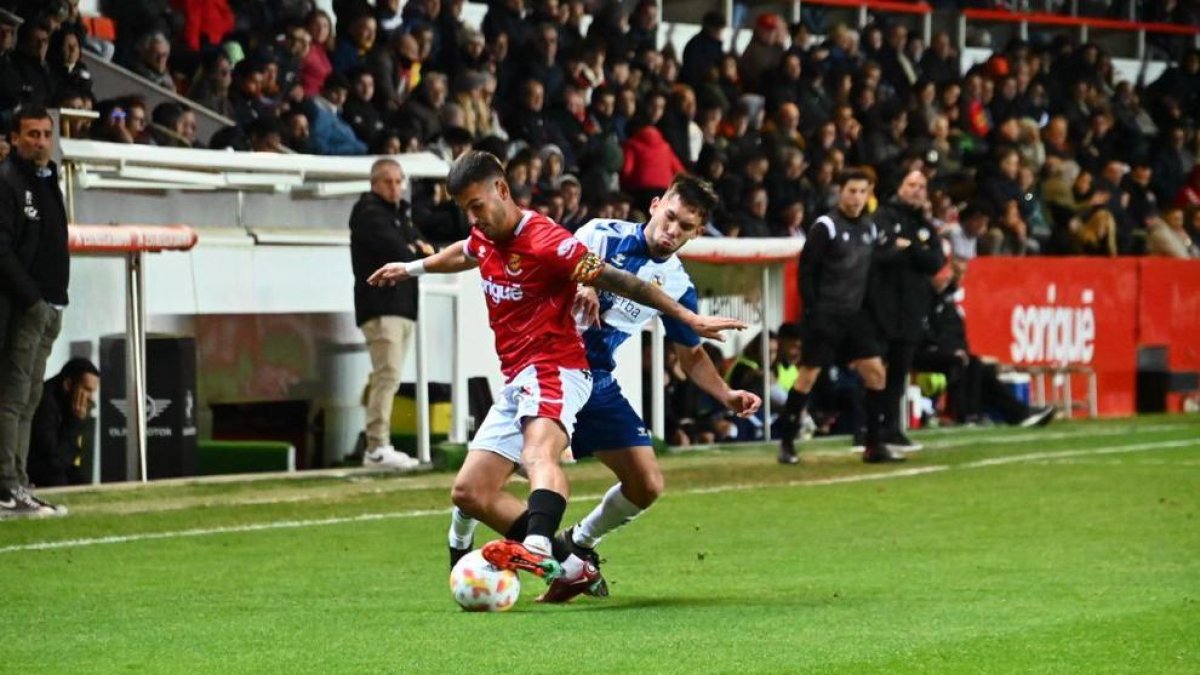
[468,365,592,464]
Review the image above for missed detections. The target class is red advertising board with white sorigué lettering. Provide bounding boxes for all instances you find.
[962,258,1140,416]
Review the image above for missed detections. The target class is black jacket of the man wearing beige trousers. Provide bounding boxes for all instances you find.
[350,192,425,325]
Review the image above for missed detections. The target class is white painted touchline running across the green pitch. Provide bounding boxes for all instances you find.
[0,432,1200,554]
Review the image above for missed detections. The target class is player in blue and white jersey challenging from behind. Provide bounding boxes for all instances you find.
[450,174,762,603]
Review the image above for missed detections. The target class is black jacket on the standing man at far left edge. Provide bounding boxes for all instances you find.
[0,151,71,347]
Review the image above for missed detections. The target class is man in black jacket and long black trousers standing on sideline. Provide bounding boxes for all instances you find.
[866,171,946,452]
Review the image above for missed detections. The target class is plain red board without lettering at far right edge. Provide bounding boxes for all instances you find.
[1138,258,1200,371]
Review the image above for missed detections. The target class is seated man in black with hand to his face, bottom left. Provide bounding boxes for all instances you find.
[29,358,100,488]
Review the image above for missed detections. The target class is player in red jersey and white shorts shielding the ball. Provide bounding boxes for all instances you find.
[370,151,745,580]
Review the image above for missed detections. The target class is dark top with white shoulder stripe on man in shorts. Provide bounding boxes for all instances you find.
[800,210,876,317]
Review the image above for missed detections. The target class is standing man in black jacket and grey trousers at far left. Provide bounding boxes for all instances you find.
[0,107,71,518]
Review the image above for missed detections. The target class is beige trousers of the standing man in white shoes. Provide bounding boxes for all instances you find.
[361,316,416,449]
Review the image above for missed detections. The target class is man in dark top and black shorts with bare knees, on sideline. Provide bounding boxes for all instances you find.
[779,171,905,464]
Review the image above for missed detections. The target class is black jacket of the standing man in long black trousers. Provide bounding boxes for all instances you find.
[866,199,946,342]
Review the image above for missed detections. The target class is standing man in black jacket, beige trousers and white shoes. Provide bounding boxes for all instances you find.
[350,160,433,468]
